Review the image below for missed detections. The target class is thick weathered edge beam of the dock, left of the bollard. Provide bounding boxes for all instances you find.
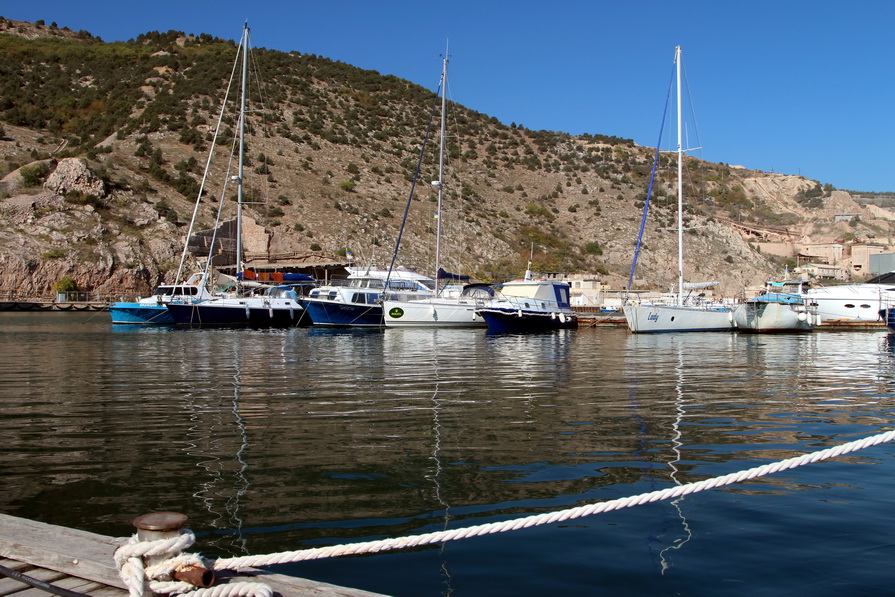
[0,514,126,589]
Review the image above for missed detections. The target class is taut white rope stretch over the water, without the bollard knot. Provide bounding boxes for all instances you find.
[214,430,895,570]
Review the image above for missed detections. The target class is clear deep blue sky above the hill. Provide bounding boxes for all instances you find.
[7,0,895,191]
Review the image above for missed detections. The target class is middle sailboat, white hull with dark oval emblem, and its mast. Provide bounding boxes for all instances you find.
[382,51,494,328]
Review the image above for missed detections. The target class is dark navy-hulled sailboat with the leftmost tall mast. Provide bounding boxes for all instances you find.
[166,24,310,327]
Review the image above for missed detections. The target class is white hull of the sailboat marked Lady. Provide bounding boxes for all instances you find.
[622,304,733,333]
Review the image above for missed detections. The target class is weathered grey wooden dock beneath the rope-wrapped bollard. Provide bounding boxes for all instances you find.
[0,514,382,597]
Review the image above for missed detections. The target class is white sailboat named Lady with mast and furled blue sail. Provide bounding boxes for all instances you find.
[622,46,733,333]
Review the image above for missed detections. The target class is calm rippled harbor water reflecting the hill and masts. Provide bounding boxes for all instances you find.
[0,313,895,597]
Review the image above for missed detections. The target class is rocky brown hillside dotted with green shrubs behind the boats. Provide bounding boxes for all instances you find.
[0,17,892,294]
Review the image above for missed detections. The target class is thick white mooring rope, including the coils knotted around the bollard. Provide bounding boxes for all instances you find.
[115,430,895,597]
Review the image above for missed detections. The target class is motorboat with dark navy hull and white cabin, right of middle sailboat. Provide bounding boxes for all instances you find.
[476,270,578,334]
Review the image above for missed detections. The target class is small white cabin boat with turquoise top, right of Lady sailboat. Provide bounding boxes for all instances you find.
[733,280,820,333]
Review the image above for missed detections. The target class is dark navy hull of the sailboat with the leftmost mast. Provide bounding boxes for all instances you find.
[168,299,308,328]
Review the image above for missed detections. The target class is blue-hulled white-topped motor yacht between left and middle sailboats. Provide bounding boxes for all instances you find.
[305,267,435,328]
